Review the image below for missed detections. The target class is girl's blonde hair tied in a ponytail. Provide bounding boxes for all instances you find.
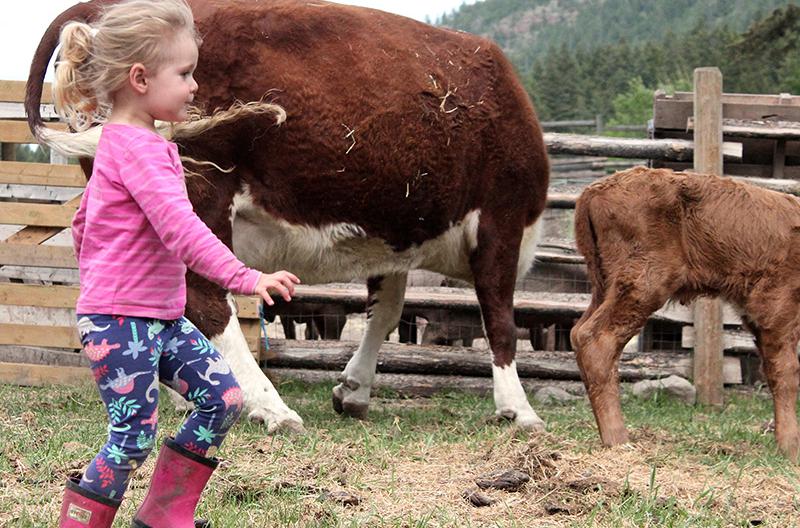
[53,0,200,131]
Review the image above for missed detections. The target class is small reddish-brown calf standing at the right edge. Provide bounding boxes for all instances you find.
[571,167,800,460]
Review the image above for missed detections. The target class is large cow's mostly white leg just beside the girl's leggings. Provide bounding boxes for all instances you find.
[186,282,304,433]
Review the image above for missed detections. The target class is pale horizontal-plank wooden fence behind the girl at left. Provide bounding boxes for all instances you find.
[0,81,261,385]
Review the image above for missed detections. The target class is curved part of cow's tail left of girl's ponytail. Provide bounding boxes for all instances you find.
[25,2,108,157]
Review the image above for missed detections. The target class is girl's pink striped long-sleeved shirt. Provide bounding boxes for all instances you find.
[72,123,261,319]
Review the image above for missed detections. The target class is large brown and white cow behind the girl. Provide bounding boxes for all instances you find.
[26,0,549,430]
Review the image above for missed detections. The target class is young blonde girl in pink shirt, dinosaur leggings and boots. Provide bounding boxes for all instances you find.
[55,0,299,528]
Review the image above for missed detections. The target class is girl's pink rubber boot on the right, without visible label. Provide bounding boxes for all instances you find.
[132,438,219,528]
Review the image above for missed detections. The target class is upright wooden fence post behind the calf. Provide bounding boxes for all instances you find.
[693,68,723,406]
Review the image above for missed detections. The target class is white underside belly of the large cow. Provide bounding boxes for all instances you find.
[232,190,480,284]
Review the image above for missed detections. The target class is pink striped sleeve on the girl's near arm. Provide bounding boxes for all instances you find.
[119,136,261,294]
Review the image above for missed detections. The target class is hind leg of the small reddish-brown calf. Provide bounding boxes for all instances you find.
[570,276,668,446]
